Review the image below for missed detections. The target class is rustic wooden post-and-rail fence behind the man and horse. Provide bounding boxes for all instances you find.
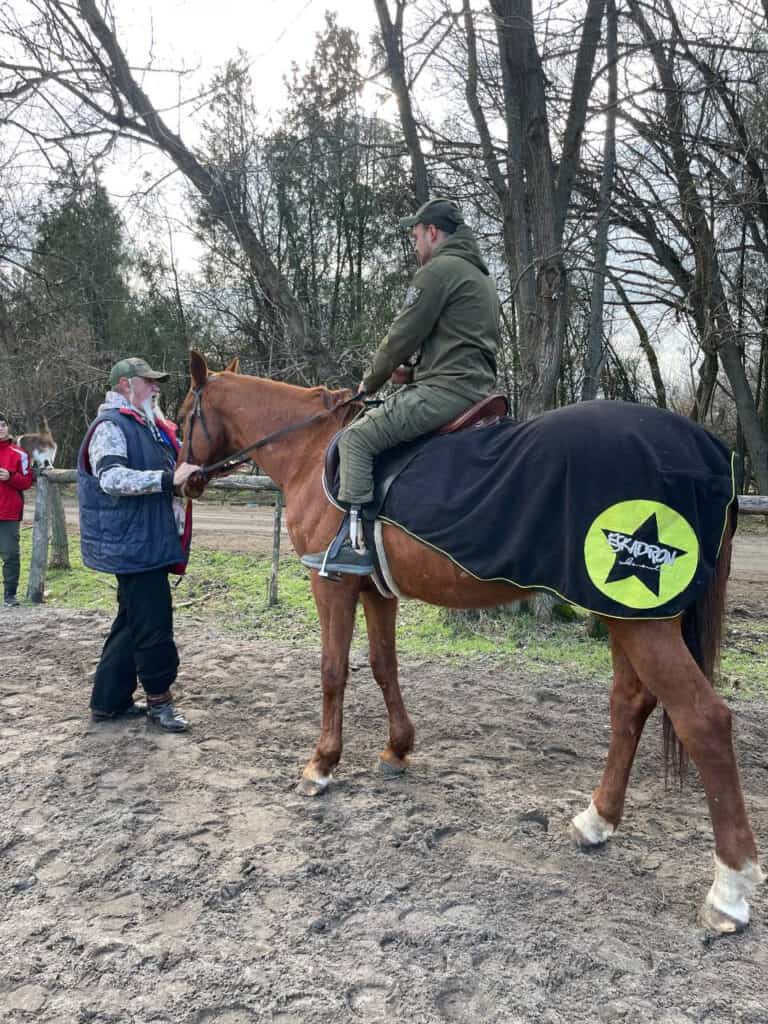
[27,469,768,605]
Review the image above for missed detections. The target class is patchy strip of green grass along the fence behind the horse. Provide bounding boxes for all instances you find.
[22,530,768,695]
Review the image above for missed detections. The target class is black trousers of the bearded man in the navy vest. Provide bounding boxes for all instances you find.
[91,569,178,712]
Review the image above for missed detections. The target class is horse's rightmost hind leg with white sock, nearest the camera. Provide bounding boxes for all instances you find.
[611,620,765,933]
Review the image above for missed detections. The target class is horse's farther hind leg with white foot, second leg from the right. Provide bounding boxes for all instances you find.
[570,627,656,849]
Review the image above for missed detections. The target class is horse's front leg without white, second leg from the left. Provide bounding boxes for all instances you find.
[361,589,415,775]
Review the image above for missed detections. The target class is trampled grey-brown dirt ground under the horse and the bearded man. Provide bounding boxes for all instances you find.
[0,520,768,1024]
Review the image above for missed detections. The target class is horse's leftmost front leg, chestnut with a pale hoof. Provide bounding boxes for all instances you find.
[297,572,360,797]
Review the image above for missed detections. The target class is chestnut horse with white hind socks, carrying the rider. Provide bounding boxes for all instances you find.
[180,352,763,932]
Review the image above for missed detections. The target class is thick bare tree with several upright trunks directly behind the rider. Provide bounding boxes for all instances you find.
[375,0,605,417]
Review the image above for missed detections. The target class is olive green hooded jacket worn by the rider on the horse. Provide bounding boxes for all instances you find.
[364,225,499,402]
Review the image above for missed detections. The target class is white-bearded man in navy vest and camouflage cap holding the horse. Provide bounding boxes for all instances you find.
[78,357,197,732]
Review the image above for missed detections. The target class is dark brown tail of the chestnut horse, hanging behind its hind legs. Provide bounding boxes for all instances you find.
[664,506,736,785]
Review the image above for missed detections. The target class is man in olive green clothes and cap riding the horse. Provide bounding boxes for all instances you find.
[301,199,499,575]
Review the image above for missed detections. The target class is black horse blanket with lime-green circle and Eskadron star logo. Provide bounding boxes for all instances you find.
[377,401,735,618]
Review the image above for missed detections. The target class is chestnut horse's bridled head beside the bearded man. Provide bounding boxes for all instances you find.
[178,349,240,498]
